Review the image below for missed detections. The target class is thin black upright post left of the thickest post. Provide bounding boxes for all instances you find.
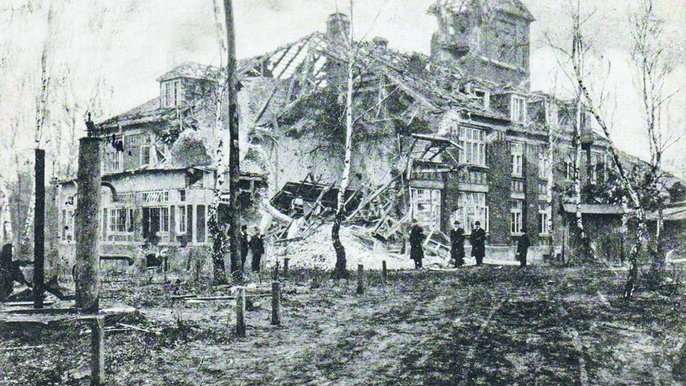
[33,149,45,308]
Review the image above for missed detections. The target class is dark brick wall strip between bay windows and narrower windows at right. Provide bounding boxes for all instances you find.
[486,140,512,245]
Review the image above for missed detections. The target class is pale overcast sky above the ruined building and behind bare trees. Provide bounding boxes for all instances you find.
[0,0,686,176]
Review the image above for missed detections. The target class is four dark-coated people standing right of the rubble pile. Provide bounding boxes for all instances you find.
[410,220,531,269]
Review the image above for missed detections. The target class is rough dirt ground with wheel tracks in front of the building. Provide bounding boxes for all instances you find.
[0,266,686,385]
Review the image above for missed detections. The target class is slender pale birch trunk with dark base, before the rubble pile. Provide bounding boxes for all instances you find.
[331,0,355,279]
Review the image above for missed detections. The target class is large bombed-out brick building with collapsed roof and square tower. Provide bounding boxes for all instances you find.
[59,0,644,264]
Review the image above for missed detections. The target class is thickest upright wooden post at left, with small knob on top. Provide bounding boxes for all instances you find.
[74,131,100,312]
